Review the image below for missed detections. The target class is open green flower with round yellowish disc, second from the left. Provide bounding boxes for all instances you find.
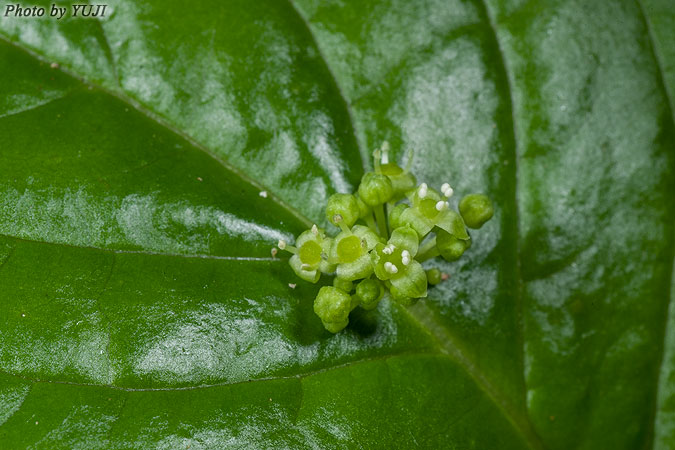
[328,225,381,281]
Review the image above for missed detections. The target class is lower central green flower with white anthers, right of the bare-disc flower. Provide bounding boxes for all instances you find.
[370,226,427,298]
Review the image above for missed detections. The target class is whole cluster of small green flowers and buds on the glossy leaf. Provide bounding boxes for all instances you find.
[278,145,493,333]
